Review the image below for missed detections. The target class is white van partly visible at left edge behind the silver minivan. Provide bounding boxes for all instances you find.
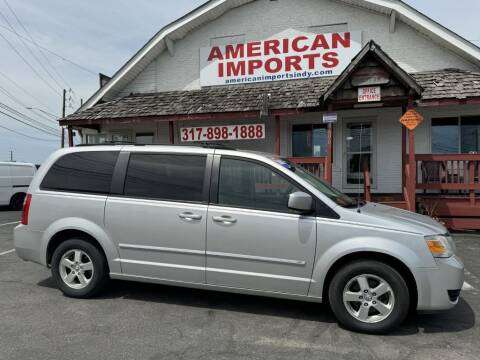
[0,162,36,210]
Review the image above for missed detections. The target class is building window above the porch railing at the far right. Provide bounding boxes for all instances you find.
[432,116,480,154]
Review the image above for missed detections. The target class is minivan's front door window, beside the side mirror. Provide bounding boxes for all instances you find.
[218,158,300,213]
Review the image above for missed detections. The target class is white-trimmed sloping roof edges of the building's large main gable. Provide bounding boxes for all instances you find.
[79,0,480,111]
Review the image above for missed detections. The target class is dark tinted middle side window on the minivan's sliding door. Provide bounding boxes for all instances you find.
[125,154,206,202]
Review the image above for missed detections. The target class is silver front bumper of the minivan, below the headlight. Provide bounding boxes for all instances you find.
[415,256,465,311]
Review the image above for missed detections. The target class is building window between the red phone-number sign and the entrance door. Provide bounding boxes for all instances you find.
[292,124,328,157]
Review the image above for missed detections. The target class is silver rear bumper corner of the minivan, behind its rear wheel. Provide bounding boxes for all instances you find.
[13,225,45,265]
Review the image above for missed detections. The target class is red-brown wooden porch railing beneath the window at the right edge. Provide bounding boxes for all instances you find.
[415,154,480,203]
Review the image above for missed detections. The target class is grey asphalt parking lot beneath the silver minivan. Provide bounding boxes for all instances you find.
[0,209,480,360]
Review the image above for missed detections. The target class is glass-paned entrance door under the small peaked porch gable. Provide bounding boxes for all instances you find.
[344,122,375,189]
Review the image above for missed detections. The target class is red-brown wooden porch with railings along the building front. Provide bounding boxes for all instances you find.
[290,154,480,230]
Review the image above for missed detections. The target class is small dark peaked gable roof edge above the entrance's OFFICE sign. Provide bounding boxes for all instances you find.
[322,40,423,102]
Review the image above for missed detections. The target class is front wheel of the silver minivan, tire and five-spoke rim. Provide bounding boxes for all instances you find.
[328,260,410,334]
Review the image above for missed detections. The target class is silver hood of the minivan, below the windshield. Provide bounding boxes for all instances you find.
[346,203,448,236]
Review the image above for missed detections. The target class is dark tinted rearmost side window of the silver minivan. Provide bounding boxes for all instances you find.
[40,151,118,194]
